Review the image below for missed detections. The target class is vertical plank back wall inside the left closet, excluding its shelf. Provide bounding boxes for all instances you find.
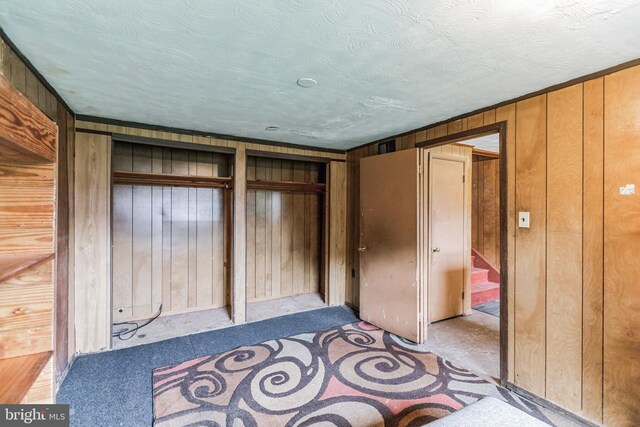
[113,141,231,321]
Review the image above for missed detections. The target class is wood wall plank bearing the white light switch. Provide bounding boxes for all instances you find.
[512,95,547,396]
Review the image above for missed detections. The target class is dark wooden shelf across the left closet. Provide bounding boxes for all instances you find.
[113,171,233,188]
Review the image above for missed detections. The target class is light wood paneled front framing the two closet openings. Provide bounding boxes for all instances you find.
[73,120,346,353]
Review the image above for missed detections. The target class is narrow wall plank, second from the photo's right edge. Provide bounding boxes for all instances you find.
[582,78,604,422]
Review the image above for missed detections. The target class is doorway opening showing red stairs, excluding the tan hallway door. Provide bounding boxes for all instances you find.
[418,124,507,381]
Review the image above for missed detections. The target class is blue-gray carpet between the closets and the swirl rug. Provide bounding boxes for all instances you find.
[57,307,358,427]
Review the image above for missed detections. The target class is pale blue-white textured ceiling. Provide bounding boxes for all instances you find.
[0,0,640,149]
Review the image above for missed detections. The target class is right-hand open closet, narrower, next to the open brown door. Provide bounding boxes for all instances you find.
[246,155,328,322]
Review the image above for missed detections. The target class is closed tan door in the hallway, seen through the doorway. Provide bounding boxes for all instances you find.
[428,153,469,322]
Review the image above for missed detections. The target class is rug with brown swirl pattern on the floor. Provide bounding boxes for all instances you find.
[153,322,544,427]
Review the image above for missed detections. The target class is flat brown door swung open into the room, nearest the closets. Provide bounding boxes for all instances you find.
[358,149,423,342]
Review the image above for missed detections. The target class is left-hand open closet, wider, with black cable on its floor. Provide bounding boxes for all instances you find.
[112,135,233,348]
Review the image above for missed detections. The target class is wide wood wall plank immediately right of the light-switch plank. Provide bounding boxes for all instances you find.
[546,84,582,412]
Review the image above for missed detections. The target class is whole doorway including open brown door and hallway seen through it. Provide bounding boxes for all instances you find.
[358,122,507,383]
